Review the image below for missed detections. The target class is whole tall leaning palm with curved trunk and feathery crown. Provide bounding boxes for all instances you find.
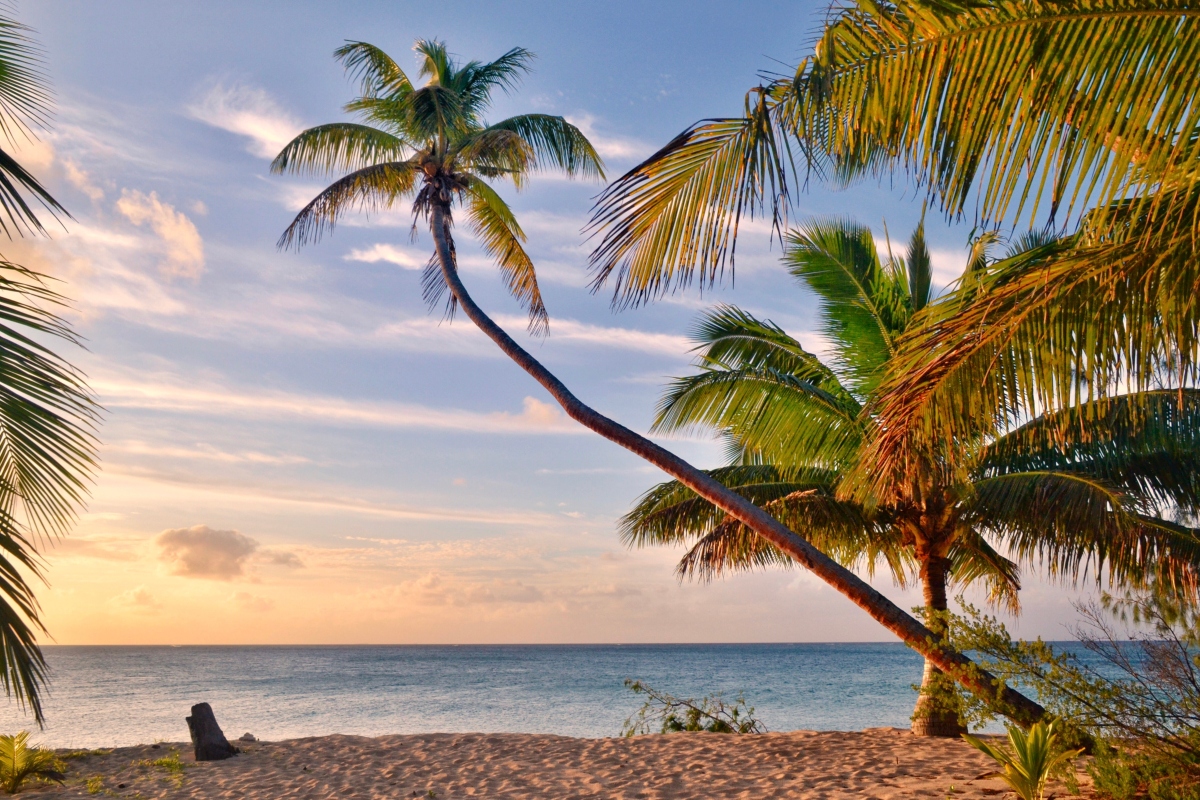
[272,41,1043,720]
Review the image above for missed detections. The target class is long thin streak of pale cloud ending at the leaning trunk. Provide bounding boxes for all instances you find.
[91,378,586,434]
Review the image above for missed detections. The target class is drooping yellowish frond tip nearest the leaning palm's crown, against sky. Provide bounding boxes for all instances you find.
[588,90,791,307]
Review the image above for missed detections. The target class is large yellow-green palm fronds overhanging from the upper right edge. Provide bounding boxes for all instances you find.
[592,0,1200,513]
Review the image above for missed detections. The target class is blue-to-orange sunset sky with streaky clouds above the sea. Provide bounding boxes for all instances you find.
[14,0,1094,644]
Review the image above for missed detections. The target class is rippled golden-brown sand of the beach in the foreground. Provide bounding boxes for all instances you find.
[32,728,1094,800]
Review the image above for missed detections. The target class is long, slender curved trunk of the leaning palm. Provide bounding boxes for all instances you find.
[430,200,1045,724]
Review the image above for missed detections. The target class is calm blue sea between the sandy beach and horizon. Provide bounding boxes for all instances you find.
[11,644,1051,747]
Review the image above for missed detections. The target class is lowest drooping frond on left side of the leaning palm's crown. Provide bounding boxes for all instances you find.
[277,161,419,249]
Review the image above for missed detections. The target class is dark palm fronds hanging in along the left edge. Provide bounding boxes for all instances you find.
[0,14,98,724]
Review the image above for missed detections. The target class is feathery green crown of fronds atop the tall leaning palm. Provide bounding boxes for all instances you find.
[271,41,604,332]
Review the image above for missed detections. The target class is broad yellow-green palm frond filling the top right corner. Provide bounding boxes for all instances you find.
[788,0,1200,227]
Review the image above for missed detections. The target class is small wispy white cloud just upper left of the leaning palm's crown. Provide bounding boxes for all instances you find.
[187,84,304,158]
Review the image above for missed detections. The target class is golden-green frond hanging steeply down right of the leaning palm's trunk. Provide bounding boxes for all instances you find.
[467,179,550,336]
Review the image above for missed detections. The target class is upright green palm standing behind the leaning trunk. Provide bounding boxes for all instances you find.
[623,221,1200,736]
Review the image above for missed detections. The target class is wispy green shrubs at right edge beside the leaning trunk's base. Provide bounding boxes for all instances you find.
[949,588,1200,800]
